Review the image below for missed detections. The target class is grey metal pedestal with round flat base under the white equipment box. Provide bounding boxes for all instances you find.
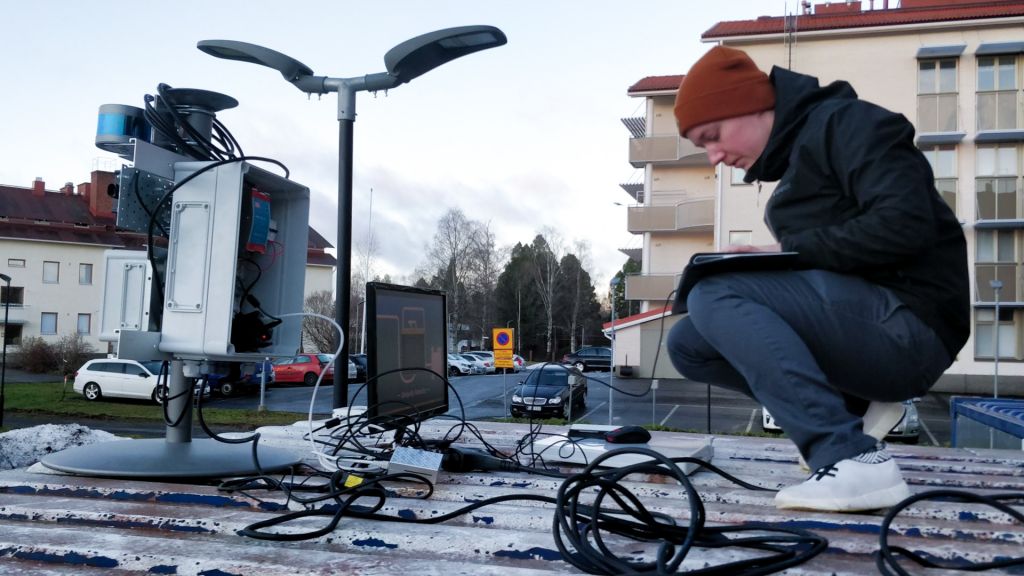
[41,360,301,480]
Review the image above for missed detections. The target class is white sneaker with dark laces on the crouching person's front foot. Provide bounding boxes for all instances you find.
[775,443,910,512]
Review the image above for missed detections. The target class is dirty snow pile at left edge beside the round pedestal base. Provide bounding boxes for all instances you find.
[0,424,123,470]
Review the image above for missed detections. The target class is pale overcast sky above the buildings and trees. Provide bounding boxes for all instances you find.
[0,0,797,294]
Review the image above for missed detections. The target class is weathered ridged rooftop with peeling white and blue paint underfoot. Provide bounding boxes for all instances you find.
[0,422,1024,576]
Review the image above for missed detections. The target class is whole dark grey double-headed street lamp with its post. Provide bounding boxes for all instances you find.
[197,26,508,408]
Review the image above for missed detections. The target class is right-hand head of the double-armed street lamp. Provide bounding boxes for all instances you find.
[384,26,508,84]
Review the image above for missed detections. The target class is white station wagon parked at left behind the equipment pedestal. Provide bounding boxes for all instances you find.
[72,358,210,404]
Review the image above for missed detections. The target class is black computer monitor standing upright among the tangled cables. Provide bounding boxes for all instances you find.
[367,282,449,428]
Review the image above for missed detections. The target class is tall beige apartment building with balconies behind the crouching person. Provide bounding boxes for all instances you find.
[615,0,1024,394]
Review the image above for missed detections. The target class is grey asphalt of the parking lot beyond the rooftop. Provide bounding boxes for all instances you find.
[4,364,950,446]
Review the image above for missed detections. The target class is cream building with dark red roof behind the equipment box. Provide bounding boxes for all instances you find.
[0,170,335,353]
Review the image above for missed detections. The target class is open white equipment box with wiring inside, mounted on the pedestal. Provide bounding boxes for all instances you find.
[160,162,309,360]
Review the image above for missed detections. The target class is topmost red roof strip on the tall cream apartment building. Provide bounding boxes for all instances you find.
[700,0,1024,40]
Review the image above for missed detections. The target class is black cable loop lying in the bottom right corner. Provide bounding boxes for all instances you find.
[874,489,1024,576]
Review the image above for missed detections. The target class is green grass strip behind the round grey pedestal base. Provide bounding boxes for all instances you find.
[4,382,308,428]
